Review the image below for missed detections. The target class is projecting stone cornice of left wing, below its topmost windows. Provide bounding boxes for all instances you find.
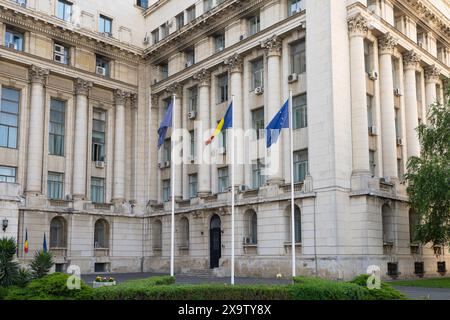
[0,3,143,63]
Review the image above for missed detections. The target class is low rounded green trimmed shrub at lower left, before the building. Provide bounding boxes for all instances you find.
[5,273,94,300]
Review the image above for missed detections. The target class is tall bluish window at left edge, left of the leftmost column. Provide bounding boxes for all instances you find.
[0,87,20,149]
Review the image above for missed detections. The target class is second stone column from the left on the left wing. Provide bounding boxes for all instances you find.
[72,79,92,200]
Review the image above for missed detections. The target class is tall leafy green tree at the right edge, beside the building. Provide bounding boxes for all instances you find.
[406,85,450,246]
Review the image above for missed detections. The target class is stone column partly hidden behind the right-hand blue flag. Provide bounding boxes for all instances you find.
[261,35,283,184]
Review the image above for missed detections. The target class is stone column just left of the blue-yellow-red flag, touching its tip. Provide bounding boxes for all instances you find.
[194,69,211,197]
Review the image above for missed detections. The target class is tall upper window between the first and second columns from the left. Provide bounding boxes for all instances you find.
[48,99,66,156]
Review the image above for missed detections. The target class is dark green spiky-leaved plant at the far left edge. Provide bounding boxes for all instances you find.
[0,238,19,287]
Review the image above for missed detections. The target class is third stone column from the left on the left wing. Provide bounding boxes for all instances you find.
[113,90,127,203]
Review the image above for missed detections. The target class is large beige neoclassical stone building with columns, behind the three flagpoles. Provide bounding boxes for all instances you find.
[0,0,450,279]
